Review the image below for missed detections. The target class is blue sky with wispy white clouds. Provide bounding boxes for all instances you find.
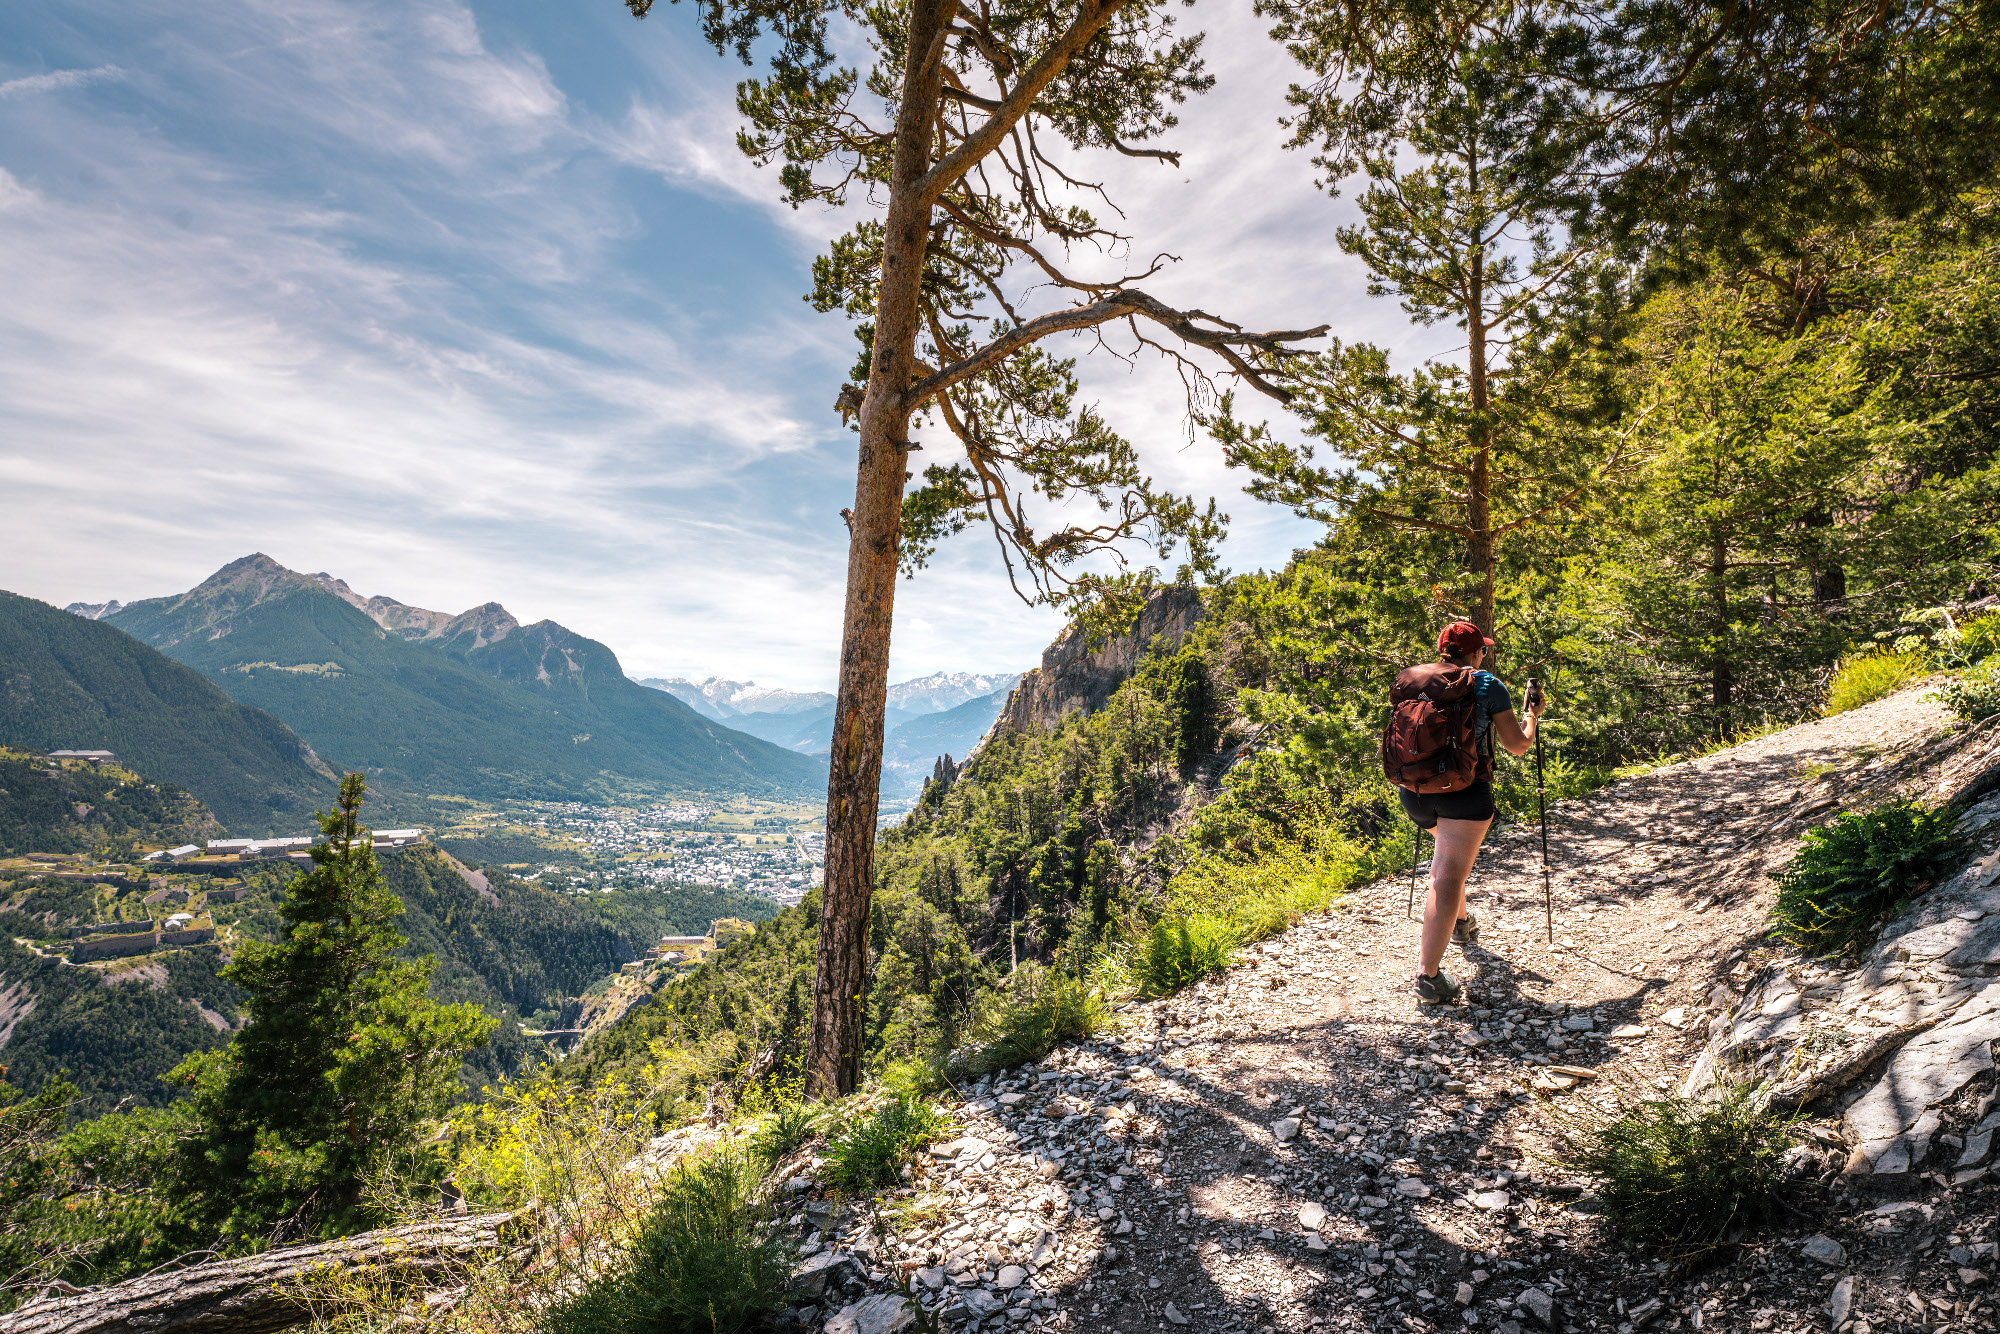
[0,0,1440,688]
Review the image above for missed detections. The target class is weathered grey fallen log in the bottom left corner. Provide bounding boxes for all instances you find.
[0,1214,514,1334]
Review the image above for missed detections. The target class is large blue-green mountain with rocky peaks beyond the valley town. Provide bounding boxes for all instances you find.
[70,554,826,820]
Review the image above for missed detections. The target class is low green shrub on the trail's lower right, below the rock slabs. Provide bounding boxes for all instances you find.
[1558,1088,1792,1256]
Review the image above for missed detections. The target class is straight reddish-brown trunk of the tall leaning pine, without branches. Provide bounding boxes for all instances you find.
[806,0,950,1098]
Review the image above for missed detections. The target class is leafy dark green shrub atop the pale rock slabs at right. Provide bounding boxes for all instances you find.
[1772,802,1952,956]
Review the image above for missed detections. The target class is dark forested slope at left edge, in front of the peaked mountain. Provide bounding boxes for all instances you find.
[0,592,334,836]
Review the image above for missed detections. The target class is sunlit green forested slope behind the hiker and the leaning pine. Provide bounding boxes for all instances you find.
[552,206,2000,1096]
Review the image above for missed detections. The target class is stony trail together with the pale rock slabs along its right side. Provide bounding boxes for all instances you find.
[788,688,2000,1334]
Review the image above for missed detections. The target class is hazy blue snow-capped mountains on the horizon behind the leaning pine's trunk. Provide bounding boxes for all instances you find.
[640,672,1020,796]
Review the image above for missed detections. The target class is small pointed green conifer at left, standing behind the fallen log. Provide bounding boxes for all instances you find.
[176,774,494,1236]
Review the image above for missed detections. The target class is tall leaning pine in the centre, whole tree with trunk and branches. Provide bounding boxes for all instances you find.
[626,0,1322,1096]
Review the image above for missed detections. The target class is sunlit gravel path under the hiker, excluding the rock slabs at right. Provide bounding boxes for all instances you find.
[802,692,2000,1334]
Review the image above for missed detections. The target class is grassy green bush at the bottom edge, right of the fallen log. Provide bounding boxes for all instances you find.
[540,1152,796,1334]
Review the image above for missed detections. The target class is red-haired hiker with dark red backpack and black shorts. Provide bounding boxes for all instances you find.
[1382,620,1546,1002]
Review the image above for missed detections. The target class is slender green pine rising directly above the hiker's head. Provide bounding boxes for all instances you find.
[1212,14,1622,632]
